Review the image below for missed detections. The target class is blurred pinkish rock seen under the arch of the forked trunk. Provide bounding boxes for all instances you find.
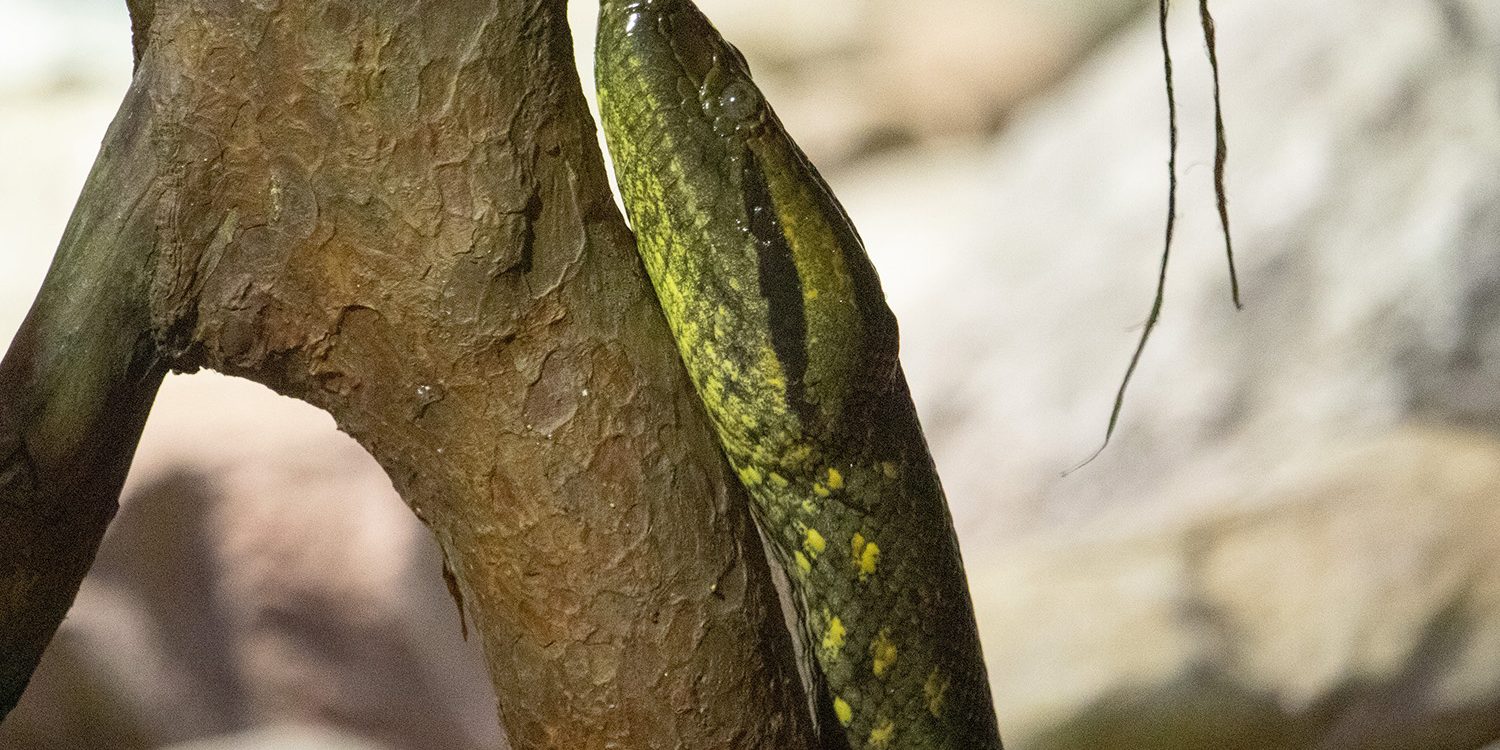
[0,374,503,750]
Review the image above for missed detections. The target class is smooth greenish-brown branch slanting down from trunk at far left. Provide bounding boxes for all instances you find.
[0,76,164,717]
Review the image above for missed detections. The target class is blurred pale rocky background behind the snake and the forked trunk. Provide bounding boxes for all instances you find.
[0,0,1500,750]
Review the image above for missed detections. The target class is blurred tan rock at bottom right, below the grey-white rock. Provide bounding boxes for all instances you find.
[977,428,1500,750]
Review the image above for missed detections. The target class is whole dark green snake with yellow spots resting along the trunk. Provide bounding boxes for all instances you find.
[596,0,1001,750]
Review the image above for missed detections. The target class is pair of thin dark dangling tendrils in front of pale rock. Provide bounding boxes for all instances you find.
[1062,0,1245,476]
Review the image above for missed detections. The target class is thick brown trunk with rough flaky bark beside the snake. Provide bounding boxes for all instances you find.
[0,0,813,749]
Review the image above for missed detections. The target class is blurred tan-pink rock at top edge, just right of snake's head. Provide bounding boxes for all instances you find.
[569,0,1149,170]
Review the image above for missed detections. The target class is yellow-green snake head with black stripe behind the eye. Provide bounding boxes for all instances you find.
[596,0,897,455]
